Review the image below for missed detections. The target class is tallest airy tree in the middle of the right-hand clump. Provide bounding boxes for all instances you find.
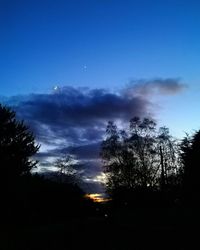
[128,117,158,188]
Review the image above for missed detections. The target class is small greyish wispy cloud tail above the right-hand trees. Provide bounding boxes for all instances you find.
[124,78,187,97]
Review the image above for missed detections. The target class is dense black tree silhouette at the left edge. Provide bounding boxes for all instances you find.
[0,105,39,182]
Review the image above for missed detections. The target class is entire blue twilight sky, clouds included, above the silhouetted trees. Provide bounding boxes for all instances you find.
[0,0,200,188]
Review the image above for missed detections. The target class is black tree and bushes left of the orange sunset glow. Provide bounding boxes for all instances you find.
[0,106,93,224]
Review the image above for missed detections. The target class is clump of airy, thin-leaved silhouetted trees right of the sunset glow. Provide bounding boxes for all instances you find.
[101,117,178,197]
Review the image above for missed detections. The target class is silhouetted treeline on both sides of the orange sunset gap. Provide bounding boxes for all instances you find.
[0,105,200,223]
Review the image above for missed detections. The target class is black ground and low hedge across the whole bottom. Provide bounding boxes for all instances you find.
[0,177,200,250]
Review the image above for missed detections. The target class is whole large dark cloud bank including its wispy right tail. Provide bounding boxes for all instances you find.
[3,78,186,183]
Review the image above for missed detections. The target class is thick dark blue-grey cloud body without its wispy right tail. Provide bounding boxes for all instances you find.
[10,87,150,144]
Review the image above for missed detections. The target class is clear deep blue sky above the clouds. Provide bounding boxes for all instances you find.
[0,0,200,95]
